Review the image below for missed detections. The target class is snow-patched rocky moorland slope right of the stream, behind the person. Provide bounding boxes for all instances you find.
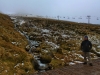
[12,17,100,69]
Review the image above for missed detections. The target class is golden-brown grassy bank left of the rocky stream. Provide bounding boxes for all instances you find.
[0,13,34,75]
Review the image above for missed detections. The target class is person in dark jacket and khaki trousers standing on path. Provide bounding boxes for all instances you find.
[81,36,93,66]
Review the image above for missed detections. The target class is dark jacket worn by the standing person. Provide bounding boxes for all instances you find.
[81,40,92,52]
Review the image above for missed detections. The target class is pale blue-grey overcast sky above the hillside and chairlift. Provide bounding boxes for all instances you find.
[0,0,100,24]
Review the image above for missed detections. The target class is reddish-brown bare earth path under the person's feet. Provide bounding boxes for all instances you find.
[30,58,100,75]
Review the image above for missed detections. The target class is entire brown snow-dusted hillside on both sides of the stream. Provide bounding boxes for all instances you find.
[0,14,100,75]
